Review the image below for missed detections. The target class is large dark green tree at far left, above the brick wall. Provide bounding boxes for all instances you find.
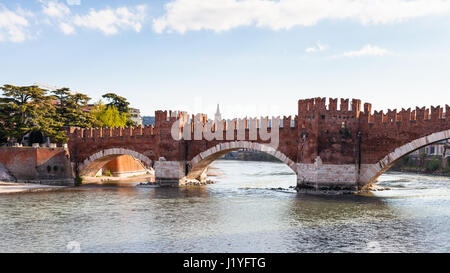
[0,85,67,142]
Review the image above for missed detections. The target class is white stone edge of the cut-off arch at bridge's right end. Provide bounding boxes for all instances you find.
[360,129,450,185]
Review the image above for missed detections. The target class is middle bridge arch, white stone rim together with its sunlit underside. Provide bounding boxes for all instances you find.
[186,141,297,181]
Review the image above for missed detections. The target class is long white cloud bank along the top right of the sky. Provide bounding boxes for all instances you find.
[153,0,450,33]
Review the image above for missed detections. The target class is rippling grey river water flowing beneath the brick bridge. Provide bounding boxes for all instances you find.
[0,160,450,252]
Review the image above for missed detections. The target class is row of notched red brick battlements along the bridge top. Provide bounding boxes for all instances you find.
[67,101,450,139]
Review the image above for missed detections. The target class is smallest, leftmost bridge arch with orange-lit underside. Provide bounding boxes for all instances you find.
[78,148,153,176]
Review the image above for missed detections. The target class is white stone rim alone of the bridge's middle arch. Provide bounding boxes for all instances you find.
[190,141,297,173]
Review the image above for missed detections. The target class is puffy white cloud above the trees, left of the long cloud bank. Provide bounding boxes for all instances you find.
[73,5,146,35]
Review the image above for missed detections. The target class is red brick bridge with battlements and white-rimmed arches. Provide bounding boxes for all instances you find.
[64,98,450,190]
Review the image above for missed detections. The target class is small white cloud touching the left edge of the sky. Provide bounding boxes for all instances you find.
[0,6,33,43]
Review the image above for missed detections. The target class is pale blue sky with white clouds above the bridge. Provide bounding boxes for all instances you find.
[0,0,450,118]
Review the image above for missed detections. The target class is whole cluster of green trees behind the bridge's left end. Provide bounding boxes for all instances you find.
[0,84,135,145]
